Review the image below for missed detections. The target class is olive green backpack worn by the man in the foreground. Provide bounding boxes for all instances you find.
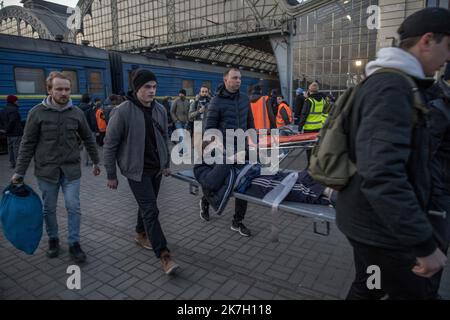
[308,68,428,190]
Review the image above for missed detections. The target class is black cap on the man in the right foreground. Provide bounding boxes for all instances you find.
[397,8,450,40]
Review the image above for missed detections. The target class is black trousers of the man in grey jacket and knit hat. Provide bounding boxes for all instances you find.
[128,171,169,258]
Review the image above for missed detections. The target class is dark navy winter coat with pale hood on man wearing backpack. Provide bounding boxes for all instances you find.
[336,48,437,257]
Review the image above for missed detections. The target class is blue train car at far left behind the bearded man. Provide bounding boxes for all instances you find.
[0,34,111,119]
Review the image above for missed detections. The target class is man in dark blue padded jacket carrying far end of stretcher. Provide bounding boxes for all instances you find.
[200,68,254,237]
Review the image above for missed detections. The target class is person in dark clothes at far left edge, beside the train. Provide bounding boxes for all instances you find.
[4,95,23,169]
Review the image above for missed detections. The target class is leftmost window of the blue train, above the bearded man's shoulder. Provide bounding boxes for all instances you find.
[14,68,46,94]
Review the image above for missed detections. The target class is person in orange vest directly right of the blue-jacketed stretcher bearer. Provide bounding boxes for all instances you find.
[250,85,275,130]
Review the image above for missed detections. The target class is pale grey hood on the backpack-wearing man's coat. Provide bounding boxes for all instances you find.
[366,48,427,80]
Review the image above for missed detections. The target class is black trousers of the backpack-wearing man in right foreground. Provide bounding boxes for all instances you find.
[347,239,442,300]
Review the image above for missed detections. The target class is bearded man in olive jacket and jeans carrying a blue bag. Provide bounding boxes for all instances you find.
[11,72,100,263]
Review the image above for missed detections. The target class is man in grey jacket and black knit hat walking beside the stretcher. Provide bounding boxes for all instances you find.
[103,69,178,274]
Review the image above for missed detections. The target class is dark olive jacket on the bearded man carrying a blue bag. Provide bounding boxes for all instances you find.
[16,96,99,183]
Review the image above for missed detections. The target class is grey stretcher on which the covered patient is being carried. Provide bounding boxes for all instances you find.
[172,170,336,236]
